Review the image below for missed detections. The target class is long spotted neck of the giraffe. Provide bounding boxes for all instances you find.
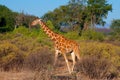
[39,21,57,40]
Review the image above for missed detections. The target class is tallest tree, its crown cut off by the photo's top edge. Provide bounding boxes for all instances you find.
[69,0,112,30]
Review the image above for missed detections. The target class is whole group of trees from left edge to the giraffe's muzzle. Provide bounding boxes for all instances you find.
[0,5,36,33]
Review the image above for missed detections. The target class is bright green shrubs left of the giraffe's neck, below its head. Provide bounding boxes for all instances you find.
[12,26,51,47]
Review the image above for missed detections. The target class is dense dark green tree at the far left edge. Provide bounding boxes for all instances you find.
[0,5,15,32]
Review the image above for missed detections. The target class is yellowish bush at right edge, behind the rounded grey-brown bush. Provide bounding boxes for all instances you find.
[80,41,120,78]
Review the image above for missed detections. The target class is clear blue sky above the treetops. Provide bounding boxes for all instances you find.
[0,0,120,24]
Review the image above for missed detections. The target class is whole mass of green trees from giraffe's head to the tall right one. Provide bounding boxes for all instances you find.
[42,0,112,30]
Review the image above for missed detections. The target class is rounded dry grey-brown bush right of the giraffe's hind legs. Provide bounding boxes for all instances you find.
[76,56,111,79]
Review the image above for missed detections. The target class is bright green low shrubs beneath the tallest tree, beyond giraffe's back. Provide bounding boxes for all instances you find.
[64,29,105,41]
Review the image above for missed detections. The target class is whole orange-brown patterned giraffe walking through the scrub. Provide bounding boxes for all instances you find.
[31,19,80,74]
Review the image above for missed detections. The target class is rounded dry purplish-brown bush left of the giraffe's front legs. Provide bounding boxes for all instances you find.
[24,48,53,70]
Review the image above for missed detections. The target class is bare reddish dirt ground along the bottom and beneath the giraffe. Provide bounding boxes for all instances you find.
[0,55,120,80]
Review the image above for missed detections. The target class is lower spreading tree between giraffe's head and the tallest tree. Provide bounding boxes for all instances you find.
[42,4,81,29]
